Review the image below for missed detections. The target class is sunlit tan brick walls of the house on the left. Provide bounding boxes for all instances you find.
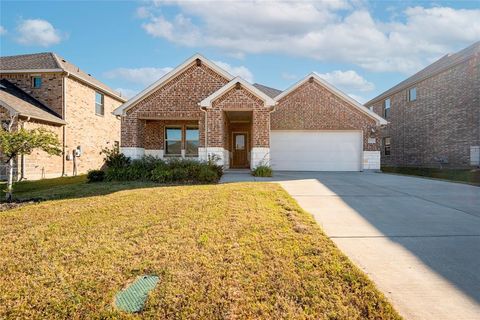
[0,73,122,179]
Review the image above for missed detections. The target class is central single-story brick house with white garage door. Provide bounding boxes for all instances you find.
[114,54,386,171]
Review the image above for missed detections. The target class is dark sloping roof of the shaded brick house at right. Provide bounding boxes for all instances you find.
[365,41,480,105]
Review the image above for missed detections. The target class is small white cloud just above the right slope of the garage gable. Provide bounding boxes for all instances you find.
[317,70,375,92]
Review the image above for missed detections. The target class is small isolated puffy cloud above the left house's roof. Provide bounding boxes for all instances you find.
[17,19,63,47]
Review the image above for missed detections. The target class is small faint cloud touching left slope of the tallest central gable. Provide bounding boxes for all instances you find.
[104,67,172,86]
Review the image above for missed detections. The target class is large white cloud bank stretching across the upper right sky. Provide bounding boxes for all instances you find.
[138,0,480,73]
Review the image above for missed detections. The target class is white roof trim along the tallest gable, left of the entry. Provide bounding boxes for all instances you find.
[113,53,234,115]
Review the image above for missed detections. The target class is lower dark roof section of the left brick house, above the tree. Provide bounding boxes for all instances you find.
[0,79,66,124]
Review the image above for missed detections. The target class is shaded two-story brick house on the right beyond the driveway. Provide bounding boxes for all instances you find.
[365,42,480,168]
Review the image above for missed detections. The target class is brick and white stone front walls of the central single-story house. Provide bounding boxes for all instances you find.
[117,58,383,169]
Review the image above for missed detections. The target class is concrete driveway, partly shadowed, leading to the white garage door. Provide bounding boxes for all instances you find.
[222,172,480,319]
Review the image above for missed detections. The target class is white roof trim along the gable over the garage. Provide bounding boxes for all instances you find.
[275,72,388,125]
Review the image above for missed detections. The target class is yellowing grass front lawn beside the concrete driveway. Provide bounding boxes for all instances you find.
[0,183,399,319]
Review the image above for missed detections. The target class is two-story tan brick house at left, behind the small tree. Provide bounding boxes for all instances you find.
[0,53,126,179]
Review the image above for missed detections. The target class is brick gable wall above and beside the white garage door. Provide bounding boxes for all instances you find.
[271,81,380,151]
